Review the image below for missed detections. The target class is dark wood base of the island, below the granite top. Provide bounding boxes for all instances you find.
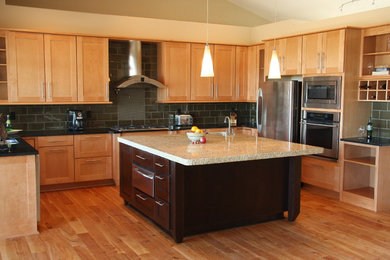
[120,143,301,243]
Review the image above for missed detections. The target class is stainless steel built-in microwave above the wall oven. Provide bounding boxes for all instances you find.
[302,76,342,109]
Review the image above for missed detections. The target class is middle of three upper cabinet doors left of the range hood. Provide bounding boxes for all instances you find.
[44,34,77,102]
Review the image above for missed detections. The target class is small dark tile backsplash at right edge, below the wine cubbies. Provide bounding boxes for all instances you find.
[371,102,390,138]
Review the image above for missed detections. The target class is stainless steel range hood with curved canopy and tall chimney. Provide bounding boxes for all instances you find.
[116,40,165,90]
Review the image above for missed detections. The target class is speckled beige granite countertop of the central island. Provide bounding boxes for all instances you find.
[118,134,323,166]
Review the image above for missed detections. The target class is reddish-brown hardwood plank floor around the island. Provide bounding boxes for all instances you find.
[0,187,390,260]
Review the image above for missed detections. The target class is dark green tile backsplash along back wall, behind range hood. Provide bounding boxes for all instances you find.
[0,41,256,130]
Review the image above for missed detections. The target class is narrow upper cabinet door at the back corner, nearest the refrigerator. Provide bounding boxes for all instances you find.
[247,46,264,101]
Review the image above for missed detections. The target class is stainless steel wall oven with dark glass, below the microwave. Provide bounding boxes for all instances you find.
[301,110,340,160]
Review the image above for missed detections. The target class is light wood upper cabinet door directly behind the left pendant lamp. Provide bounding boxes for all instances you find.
[191,43,215,101]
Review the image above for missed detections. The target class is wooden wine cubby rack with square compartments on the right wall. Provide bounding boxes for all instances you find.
[358,78,390,102]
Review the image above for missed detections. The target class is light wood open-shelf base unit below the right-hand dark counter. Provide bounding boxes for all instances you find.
[340,142,390,211]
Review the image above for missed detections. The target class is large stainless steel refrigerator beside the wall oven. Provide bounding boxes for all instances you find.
[256,80,302,143]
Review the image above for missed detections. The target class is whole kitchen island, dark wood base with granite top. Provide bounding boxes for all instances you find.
[118,134,322,243]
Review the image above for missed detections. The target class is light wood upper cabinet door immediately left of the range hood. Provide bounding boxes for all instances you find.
[77,36,109,102]
